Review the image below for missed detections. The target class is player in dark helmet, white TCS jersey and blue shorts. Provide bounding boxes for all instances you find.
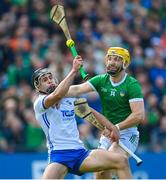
[32,56,131,179]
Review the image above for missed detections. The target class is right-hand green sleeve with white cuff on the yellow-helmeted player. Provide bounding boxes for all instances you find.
[128,81,143,100]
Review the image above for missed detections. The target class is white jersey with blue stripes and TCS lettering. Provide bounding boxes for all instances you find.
[34,95,84,153]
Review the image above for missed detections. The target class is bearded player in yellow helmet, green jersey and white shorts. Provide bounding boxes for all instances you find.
[68,47,144,179]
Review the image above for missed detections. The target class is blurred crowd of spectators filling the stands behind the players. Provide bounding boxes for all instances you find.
[0,0,166,153]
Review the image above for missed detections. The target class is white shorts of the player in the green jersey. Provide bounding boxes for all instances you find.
[98,127,139,152]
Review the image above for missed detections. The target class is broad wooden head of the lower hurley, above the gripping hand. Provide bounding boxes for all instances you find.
[74,98,105,130]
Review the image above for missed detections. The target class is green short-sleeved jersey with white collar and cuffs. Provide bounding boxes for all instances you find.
[88,74,143,124]
